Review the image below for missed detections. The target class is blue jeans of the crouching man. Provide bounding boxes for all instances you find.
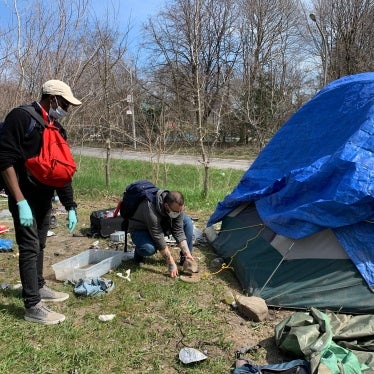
[130,215,193,257]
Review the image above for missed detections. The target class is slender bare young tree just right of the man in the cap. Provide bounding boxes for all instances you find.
[74,13,131,185]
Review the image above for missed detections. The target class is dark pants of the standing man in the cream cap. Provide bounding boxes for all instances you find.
[8,194,53,308]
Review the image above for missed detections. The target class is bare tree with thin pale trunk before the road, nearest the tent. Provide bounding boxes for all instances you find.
[143,0,239,196]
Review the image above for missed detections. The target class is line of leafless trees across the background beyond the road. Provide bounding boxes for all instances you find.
[0,0,374,193]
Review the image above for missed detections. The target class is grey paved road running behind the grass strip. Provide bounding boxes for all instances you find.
[72,147,252,170]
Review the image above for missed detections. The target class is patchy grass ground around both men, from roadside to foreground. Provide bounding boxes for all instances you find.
[0,157,284,374]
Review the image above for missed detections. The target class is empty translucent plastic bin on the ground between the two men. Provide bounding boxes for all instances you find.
[52,249,125,282]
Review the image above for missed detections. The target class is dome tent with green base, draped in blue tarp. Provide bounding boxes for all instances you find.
[207,72,374,313]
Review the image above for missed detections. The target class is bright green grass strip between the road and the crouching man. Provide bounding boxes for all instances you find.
[74,156,243,216]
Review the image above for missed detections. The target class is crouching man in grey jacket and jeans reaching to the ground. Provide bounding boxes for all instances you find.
[129,190,194,278]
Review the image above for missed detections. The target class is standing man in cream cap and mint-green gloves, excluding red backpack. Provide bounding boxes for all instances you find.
[0,80,82,325]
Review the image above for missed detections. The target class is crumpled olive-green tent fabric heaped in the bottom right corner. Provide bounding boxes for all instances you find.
[275,308,374,374]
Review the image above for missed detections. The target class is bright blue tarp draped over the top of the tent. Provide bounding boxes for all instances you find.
[207,72,374,290]
